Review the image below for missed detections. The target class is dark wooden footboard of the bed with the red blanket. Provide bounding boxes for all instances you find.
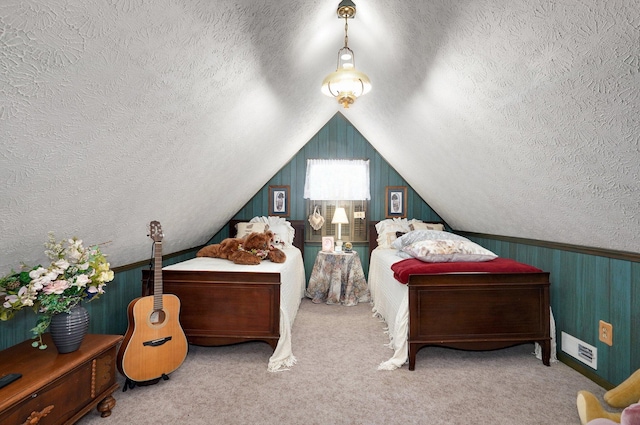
[408,273,551,370]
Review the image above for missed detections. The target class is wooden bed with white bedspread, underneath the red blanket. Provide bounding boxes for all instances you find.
[368,223,551,370]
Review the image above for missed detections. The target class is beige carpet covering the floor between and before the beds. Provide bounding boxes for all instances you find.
[79,299,604,425]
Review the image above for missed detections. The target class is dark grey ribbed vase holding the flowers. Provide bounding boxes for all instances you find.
[49,304,89,354]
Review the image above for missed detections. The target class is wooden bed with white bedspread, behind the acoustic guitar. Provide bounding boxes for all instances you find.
[142,220,305,371]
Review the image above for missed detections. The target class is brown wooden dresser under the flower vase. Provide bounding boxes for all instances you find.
[0,334,122,425]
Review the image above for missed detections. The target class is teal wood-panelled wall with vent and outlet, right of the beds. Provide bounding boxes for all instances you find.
[470,236,640,385]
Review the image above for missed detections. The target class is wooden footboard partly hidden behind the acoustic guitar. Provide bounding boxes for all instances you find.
[142,270,280,349]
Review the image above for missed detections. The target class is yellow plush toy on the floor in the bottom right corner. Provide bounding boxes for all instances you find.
[576,369,640,425]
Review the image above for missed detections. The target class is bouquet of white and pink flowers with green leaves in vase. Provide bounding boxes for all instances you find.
[0,232,113,349]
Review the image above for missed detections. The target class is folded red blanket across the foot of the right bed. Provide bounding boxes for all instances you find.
[391,257,542,284]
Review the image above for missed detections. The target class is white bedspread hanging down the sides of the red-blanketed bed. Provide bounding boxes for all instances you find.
[369,247,558,370]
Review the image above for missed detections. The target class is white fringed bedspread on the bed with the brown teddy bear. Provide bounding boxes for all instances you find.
[162,248,306,372]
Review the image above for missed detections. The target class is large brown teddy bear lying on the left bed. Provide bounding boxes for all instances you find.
[196,230,287,264]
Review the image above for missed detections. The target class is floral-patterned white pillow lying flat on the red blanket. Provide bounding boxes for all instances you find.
[402,239,497,263]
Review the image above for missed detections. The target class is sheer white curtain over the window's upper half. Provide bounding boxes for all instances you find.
[304,159,371,201]
